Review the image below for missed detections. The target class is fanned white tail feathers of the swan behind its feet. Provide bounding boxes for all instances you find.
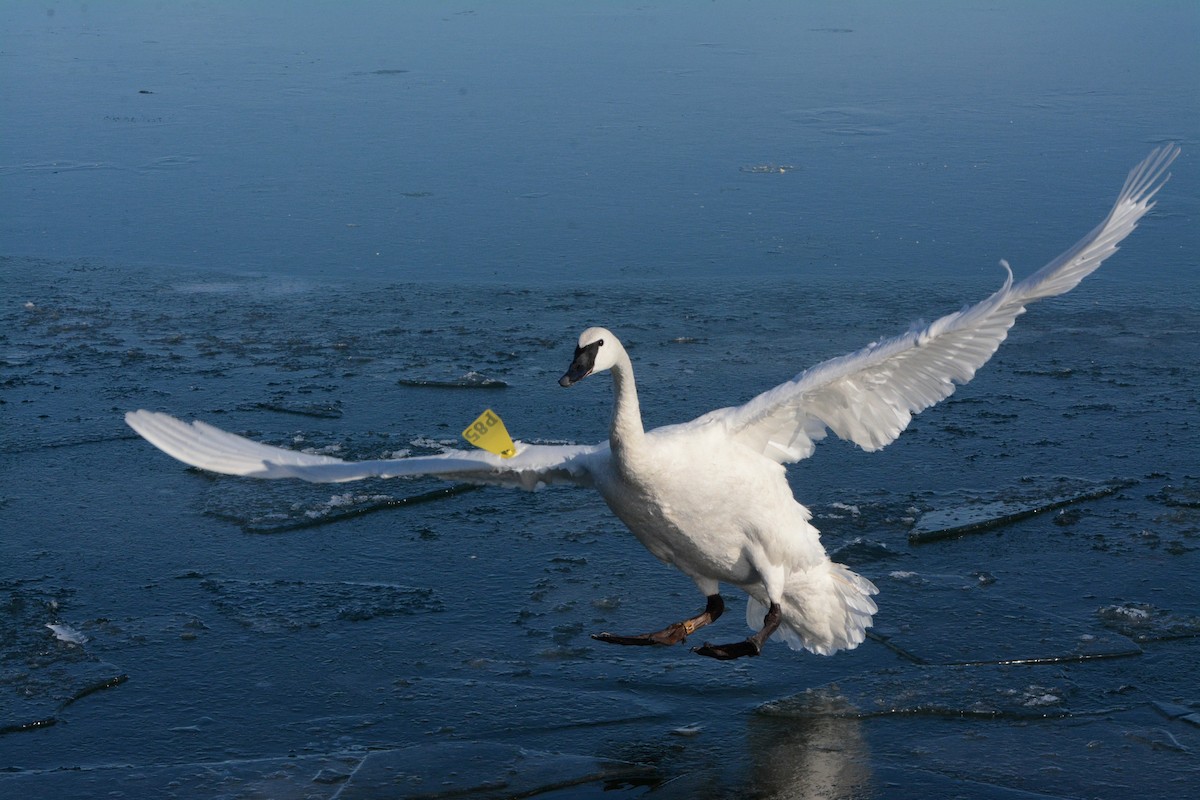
[746,561,880,656]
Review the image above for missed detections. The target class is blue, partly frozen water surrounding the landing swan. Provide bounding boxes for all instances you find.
[0,2,1200,798]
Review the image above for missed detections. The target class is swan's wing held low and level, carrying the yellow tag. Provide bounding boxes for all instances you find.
[125,410,608,491]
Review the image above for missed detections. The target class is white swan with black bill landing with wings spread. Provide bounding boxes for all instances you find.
[125,145,1178,658]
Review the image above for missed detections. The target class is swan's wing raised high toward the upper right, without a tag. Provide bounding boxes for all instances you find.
[696,145,1180,463]
